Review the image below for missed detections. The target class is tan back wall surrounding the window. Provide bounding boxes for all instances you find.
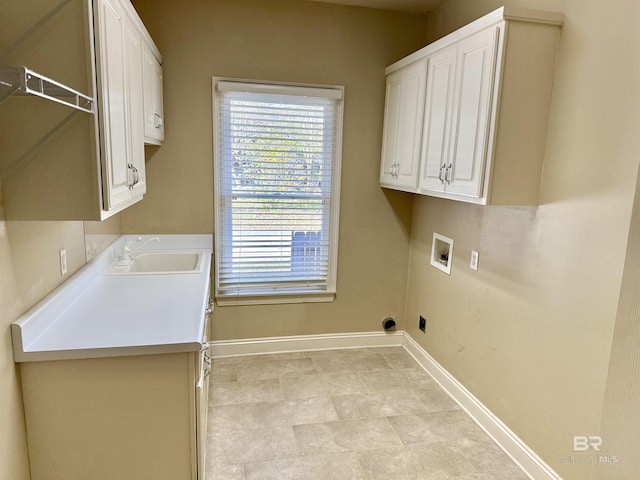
[123,0,426,339]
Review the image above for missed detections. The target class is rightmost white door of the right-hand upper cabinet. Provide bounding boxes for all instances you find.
[445,28,498,197]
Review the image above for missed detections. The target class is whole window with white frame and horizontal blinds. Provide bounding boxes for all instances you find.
[213,78,343,305]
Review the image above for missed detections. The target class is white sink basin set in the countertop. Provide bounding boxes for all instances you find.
[107,252,202,275]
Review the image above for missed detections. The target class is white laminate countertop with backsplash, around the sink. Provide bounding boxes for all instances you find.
[11,235,212,362]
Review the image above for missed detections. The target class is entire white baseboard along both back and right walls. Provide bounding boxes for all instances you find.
[209,331,562,480]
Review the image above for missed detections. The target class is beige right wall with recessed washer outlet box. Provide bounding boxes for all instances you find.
[406,0,640,480]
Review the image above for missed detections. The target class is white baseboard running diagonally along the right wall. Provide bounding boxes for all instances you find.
[404,333,562,480]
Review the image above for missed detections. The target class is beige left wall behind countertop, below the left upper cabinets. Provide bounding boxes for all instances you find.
[0,192,120,480]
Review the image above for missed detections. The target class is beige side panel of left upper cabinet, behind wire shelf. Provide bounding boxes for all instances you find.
[0,0,101,221]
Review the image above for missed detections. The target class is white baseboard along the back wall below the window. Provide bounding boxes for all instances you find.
[209,332,404,358]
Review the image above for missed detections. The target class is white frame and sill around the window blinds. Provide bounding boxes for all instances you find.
[212,77,344,306]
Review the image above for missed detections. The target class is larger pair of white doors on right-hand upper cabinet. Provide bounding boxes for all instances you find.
[419,27,498,197]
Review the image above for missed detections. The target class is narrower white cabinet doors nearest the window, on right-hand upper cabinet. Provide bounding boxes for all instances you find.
[380,60,426,191]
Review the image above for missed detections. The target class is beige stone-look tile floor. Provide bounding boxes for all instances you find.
[207,347,528,480]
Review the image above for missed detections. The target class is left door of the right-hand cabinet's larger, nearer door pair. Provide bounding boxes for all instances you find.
[419,46,457,191]
